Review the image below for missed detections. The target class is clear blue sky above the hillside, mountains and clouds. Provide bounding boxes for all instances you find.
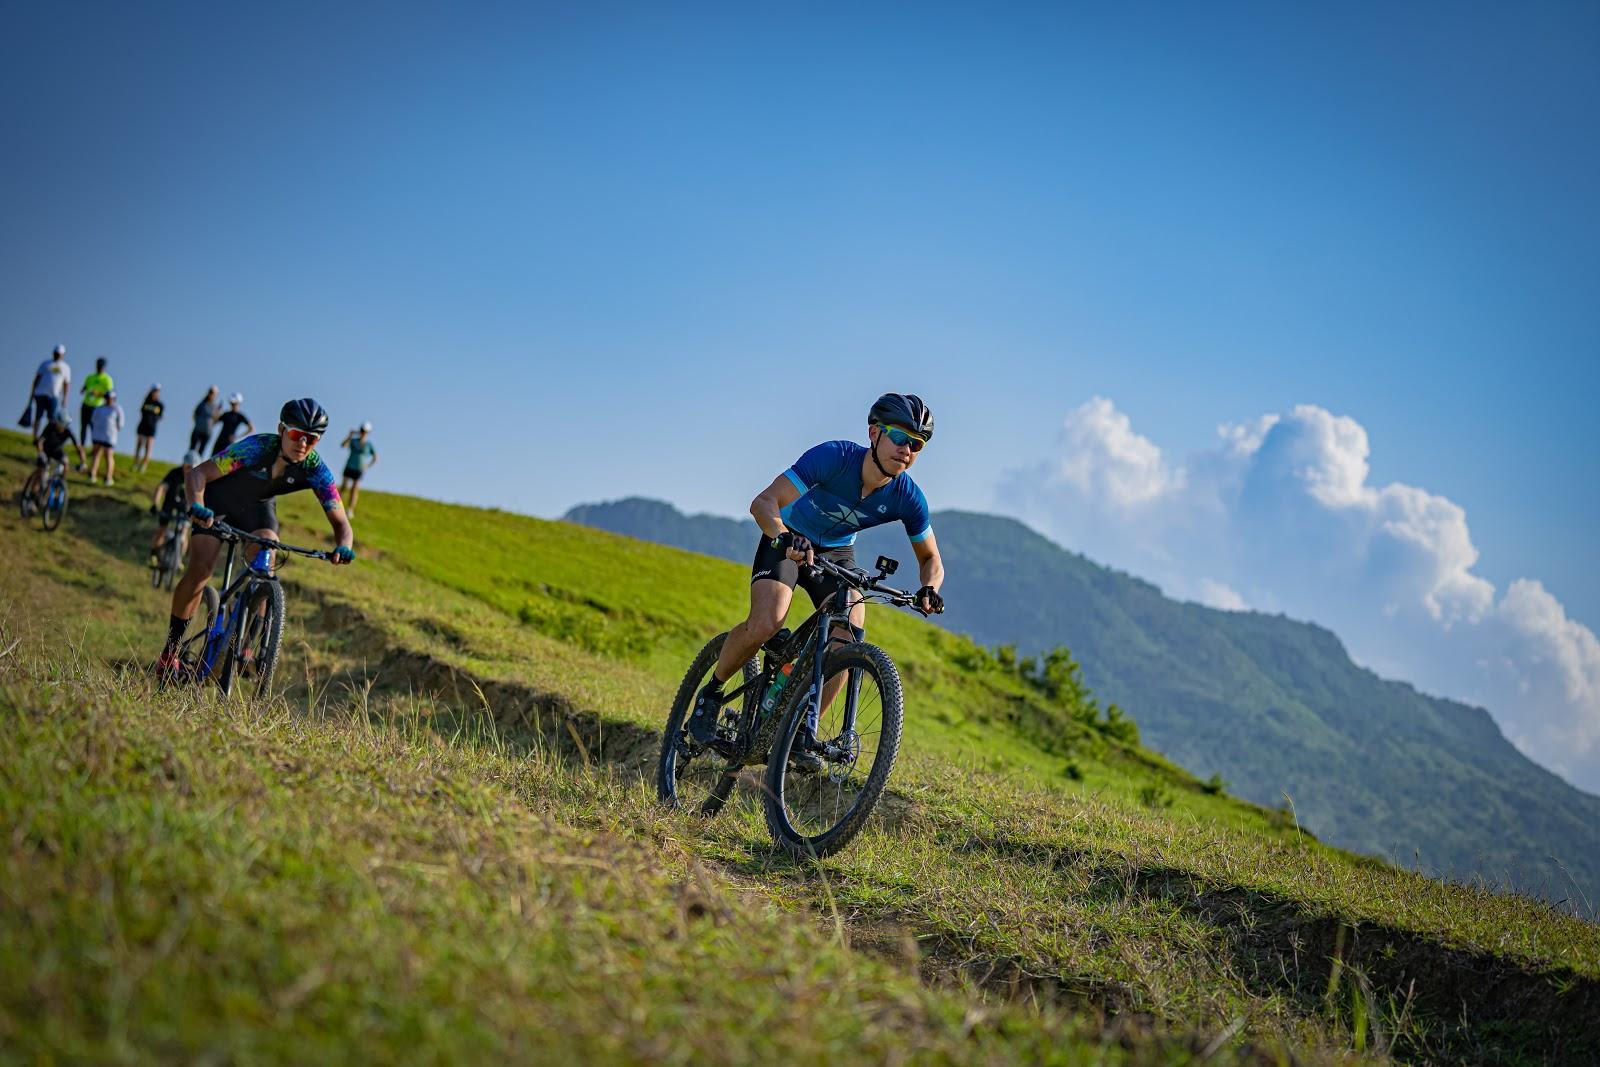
[0,3,1600,625]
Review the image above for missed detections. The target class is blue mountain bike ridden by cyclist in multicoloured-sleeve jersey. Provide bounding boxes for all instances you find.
[178,520,333,697]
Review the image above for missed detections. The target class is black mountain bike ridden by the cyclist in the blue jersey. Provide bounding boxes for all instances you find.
[656,555,934,859]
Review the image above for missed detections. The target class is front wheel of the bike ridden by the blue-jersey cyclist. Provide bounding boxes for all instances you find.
[762,643,904,859]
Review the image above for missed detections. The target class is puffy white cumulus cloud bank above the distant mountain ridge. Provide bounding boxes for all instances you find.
[998,397,1600,792]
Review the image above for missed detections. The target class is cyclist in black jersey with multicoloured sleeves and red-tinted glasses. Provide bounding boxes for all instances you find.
[155,397,355,675]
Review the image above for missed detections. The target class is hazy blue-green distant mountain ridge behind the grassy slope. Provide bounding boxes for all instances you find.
[566,498,1600,901]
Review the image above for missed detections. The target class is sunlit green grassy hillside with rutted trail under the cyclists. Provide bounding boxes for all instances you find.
[0,434,1600,1062]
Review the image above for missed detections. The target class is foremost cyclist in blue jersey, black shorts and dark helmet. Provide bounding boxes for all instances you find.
[690,394,944,750]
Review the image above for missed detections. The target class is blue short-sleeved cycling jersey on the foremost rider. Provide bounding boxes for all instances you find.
[779,442,933,549]
